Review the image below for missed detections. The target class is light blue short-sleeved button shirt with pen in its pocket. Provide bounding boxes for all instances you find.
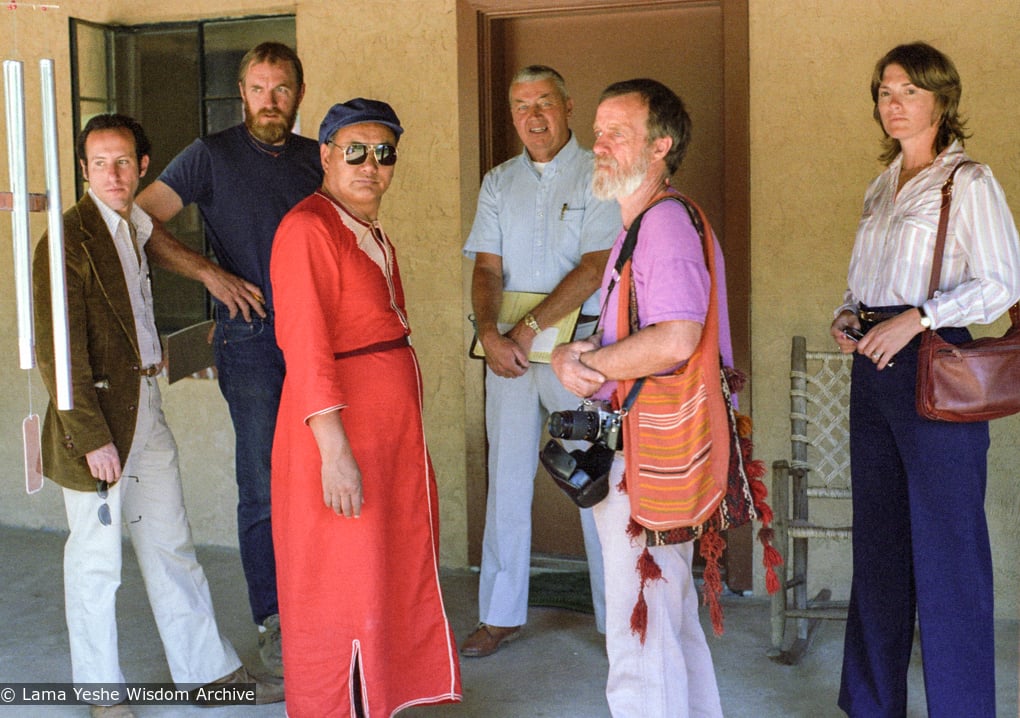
[464,134,621,314]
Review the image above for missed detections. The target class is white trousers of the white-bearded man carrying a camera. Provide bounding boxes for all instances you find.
[593,453,722,718]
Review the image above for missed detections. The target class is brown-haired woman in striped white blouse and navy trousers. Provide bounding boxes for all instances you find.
[830,43,1020,718]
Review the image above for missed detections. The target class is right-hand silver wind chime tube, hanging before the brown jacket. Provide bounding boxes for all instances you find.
[39,59,74,410]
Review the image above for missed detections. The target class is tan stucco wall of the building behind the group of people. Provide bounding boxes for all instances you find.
[0,0,1020,617]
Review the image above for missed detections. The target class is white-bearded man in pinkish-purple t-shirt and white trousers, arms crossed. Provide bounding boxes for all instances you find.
[552,80,732,718]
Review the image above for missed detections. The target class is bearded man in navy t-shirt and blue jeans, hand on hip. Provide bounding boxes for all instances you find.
[137,42,322,676]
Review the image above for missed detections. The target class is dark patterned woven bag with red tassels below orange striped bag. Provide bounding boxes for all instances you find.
[620,368,782,644]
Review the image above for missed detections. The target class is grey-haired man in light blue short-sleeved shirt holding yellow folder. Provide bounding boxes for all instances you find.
[461,65,620,657]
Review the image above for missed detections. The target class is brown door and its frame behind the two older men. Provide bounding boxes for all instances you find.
[467,0,751,587]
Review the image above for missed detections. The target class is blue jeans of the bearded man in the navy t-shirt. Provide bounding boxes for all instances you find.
[213,307,284,623]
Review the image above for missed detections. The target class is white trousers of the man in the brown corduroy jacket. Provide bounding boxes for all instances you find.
[63,377,241,685]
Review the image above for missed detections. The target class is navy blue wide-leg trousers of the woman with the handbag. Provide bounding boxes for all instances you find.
[839,329,996,718]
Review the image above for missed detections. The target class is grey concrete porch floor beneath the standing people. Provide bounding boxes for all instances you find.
[0,526,1018,718]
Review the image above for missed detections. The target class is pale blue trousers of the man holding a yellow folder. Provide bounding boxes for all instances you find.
[478,364,606,632]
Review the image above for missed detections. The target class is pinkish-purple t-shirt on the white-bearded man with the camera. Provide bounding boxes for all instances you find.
[595,195,733,399]
